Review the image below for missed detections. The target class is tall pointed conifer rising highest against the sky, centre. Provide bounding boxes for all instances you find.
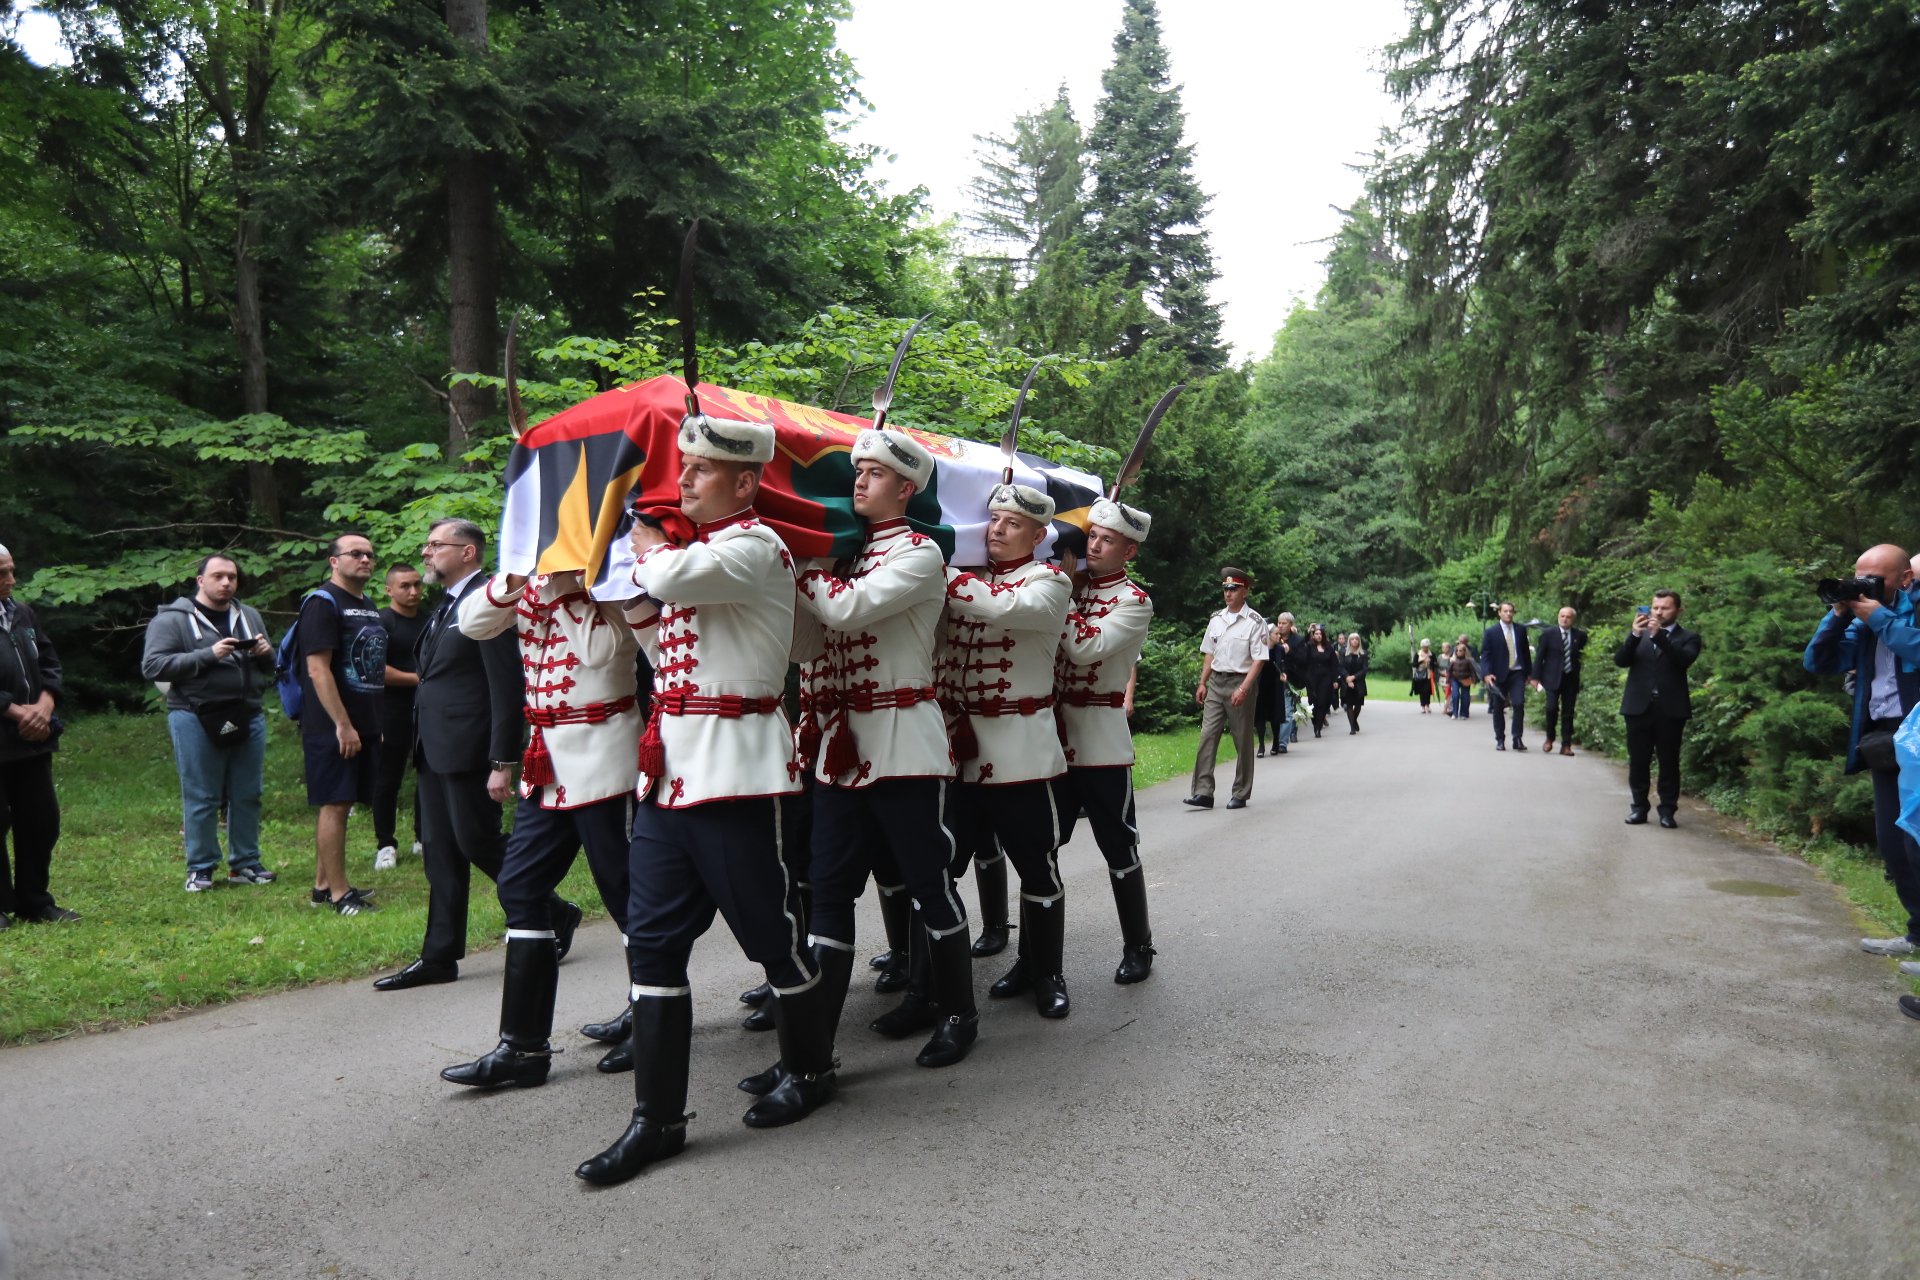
[1085,0,1225,368]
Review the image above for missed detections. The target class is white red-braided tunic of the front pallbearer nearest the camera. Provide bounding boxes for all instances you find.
[634,510,801,808]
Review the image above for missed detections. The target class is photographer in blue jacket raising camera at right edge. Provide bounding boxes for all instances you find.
[1805,543,1920,956]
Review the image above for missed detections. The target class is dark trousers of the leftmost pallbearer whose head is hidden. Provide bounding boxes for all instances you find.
[499,794,628,933]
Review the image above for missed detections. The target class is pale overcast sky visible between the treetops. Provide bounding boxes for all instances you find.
[3,0,1405,357]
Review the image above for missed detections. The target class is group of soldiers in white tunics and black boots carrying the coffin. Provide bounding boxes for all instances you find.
[416,413,1154,1184]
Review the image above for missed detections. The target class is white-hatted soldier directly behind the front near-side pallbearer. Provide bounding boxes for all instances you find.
[764,426,979,1086]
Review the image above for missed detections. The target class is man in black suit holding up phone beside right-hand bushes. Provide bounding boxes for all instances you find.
[1613,587,1699,827]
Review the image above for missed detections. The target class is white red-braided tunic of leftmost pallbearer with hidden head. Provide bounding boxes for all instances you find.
[459,572,641,810]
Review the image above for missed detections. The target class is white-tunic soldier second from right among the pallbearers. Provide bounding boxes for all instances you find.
[943,484,1073,1017]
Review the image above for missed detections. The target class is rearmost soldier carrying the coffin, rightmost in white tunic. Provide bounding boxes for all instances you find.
[1054,499,1154,983]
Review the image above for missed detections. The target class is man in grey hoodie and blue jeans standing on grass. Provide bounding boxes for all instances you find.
[140,555,275,892]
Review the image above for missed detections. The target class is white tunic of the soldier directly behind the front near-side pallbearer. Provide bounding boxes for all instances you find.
[799,520,954,787]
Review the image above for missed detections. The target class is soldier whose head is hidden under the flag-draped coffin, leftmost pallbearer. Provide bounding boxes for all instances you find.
[440,572,641,1088]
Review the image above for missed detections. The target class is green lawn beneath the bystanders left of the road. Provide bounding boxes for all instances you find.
[0,712,599,1042]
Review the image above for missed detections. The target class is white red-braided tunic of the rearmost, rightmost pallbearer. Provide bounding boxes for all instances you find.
[1054,570,1154,770]
